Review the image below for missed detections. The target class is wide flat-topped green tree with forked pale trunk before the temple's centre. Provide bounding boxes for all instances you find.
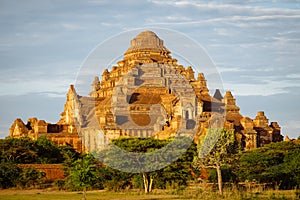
[96,137,197,193]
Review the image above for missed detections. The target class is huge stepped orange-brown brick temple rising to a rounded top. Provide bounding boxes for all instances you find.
[10,31,283,151]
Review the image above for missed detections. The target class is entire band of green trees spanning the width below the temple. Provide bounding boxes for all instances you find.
[0,134,300,193]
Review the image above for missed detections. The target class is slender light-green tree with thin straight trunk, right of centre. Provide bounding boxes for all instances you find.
[197,129,239,194]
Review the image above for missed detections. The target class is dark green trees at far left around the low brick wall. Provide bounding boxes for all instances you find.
[0,137,80,189]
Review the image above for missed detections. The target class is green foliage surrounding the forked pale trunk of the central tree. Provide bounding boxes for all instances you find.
[97,137,197,190]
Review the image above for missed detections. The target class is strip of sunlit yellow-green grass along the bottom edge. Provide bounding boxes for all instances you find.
[0,190,300,200]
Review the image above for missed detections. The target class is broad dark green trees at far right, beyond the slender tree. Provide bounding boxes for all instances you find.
[239,142,300,189]
